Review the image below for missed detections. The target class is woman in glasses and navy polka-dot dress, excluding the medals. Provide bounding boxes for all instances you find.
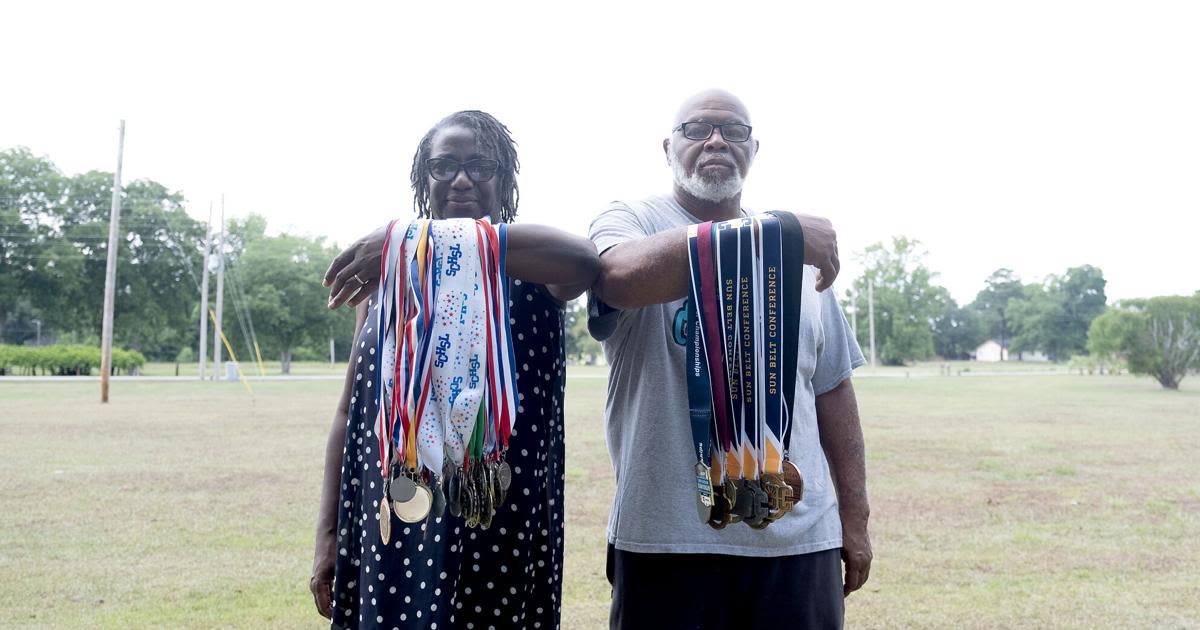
[311,112,599,629]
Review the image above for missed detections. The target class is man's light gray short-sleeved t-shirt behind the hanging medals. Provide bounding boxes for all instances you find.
[588,197,865,557]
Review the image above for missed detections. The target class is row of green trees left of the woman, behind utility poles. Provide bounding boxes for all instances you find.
[0,148,354,371]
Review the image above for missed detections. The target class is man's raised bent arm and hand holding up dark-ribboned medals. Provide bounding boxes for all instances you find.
[594,215,841,311]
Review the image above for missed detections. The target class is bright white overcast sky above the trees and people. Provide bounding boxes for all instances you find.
[0,0,1200,302]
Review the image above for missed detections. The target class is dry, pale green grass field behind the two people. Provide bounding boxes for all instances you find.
[0,368,1200,629]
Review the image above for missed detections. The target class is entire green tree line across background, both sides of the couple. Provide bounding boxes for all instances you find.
[0,148,1200,388]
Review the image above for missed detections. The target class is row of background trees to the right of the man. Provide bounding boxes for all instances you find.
[845,236,1200,389]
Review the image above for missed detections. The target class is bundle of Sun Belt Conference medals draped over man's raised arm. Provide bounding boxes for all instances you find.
[686,212,804,529]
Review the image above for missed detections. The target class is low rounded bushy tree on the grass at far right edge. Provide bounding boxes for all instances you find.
[1087,292,1200,390]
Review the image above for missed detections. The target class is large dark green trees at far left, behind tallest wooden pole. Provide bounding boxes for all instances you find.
[0,149,203,359]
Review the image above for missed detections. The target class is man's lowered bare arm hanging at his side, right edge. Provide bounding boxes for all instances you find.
[816,378,872,595]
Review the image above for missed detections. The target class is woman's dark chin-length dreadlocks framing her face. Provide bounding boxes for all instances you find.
[410,109,521,223]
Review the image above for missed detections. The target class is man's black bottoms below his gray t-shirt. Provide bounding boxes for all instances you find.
[607,545,845,630]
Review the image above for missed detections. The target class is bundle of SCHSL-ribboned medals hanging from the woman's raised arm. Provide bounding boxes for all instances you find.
[374,218,516,544]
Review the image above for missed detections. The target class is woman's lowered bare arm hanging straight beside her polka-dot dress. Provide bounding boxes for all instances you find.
[308,302,367,619]
